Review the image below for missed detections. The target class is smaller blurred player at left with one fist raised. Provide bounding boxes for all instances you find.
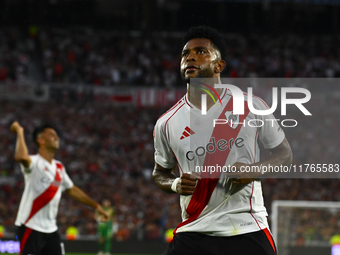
[10,122,109,255]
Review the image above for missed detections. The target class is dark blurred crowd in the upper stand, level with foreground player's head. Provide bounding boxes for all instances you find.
[0,26,340,88]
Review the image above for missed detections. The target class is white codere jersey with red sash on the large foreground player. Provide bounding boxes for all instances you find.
[154,89,285,236]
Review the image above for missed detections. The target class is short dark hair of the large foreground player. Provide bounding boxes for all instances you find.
[184,26,227,60]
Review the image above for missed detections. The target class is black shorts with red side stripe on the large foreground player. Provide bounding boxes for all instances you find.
[163,229,276,255]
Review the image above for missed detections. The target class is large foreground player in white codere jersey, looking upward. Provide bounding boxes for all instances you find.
[153,26,292,255]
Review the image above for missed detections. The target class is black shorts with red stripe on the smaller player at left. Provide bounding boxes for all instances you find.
[17,226,64,255]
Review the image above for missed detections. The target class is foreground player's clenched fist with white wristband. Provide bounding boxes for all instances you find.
[171,173,201,196]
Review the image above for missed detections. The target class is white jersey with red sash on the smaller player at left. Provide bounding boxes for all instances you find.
[15,154,73,233]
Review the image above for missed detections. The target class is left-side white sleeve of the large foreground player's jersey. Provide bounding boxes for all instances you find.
[153,120,177,169]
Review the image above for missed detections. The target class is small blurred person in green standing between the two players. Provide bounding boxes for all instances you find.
[96,199,114,255]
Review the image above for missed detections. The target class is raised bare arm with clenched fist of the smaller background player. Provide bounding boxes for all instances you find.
[10,121,32,168]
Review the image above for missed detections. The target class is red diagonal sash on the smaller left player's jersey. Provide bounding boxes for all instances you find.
[24,163,63,224]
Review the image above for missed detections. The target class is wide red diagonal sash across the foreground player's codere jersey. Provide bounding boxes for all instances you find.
[174,98,249,234]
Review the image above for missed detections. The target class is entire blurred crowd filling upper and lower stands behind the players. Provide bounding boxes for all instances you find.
[0,26,340,243]
